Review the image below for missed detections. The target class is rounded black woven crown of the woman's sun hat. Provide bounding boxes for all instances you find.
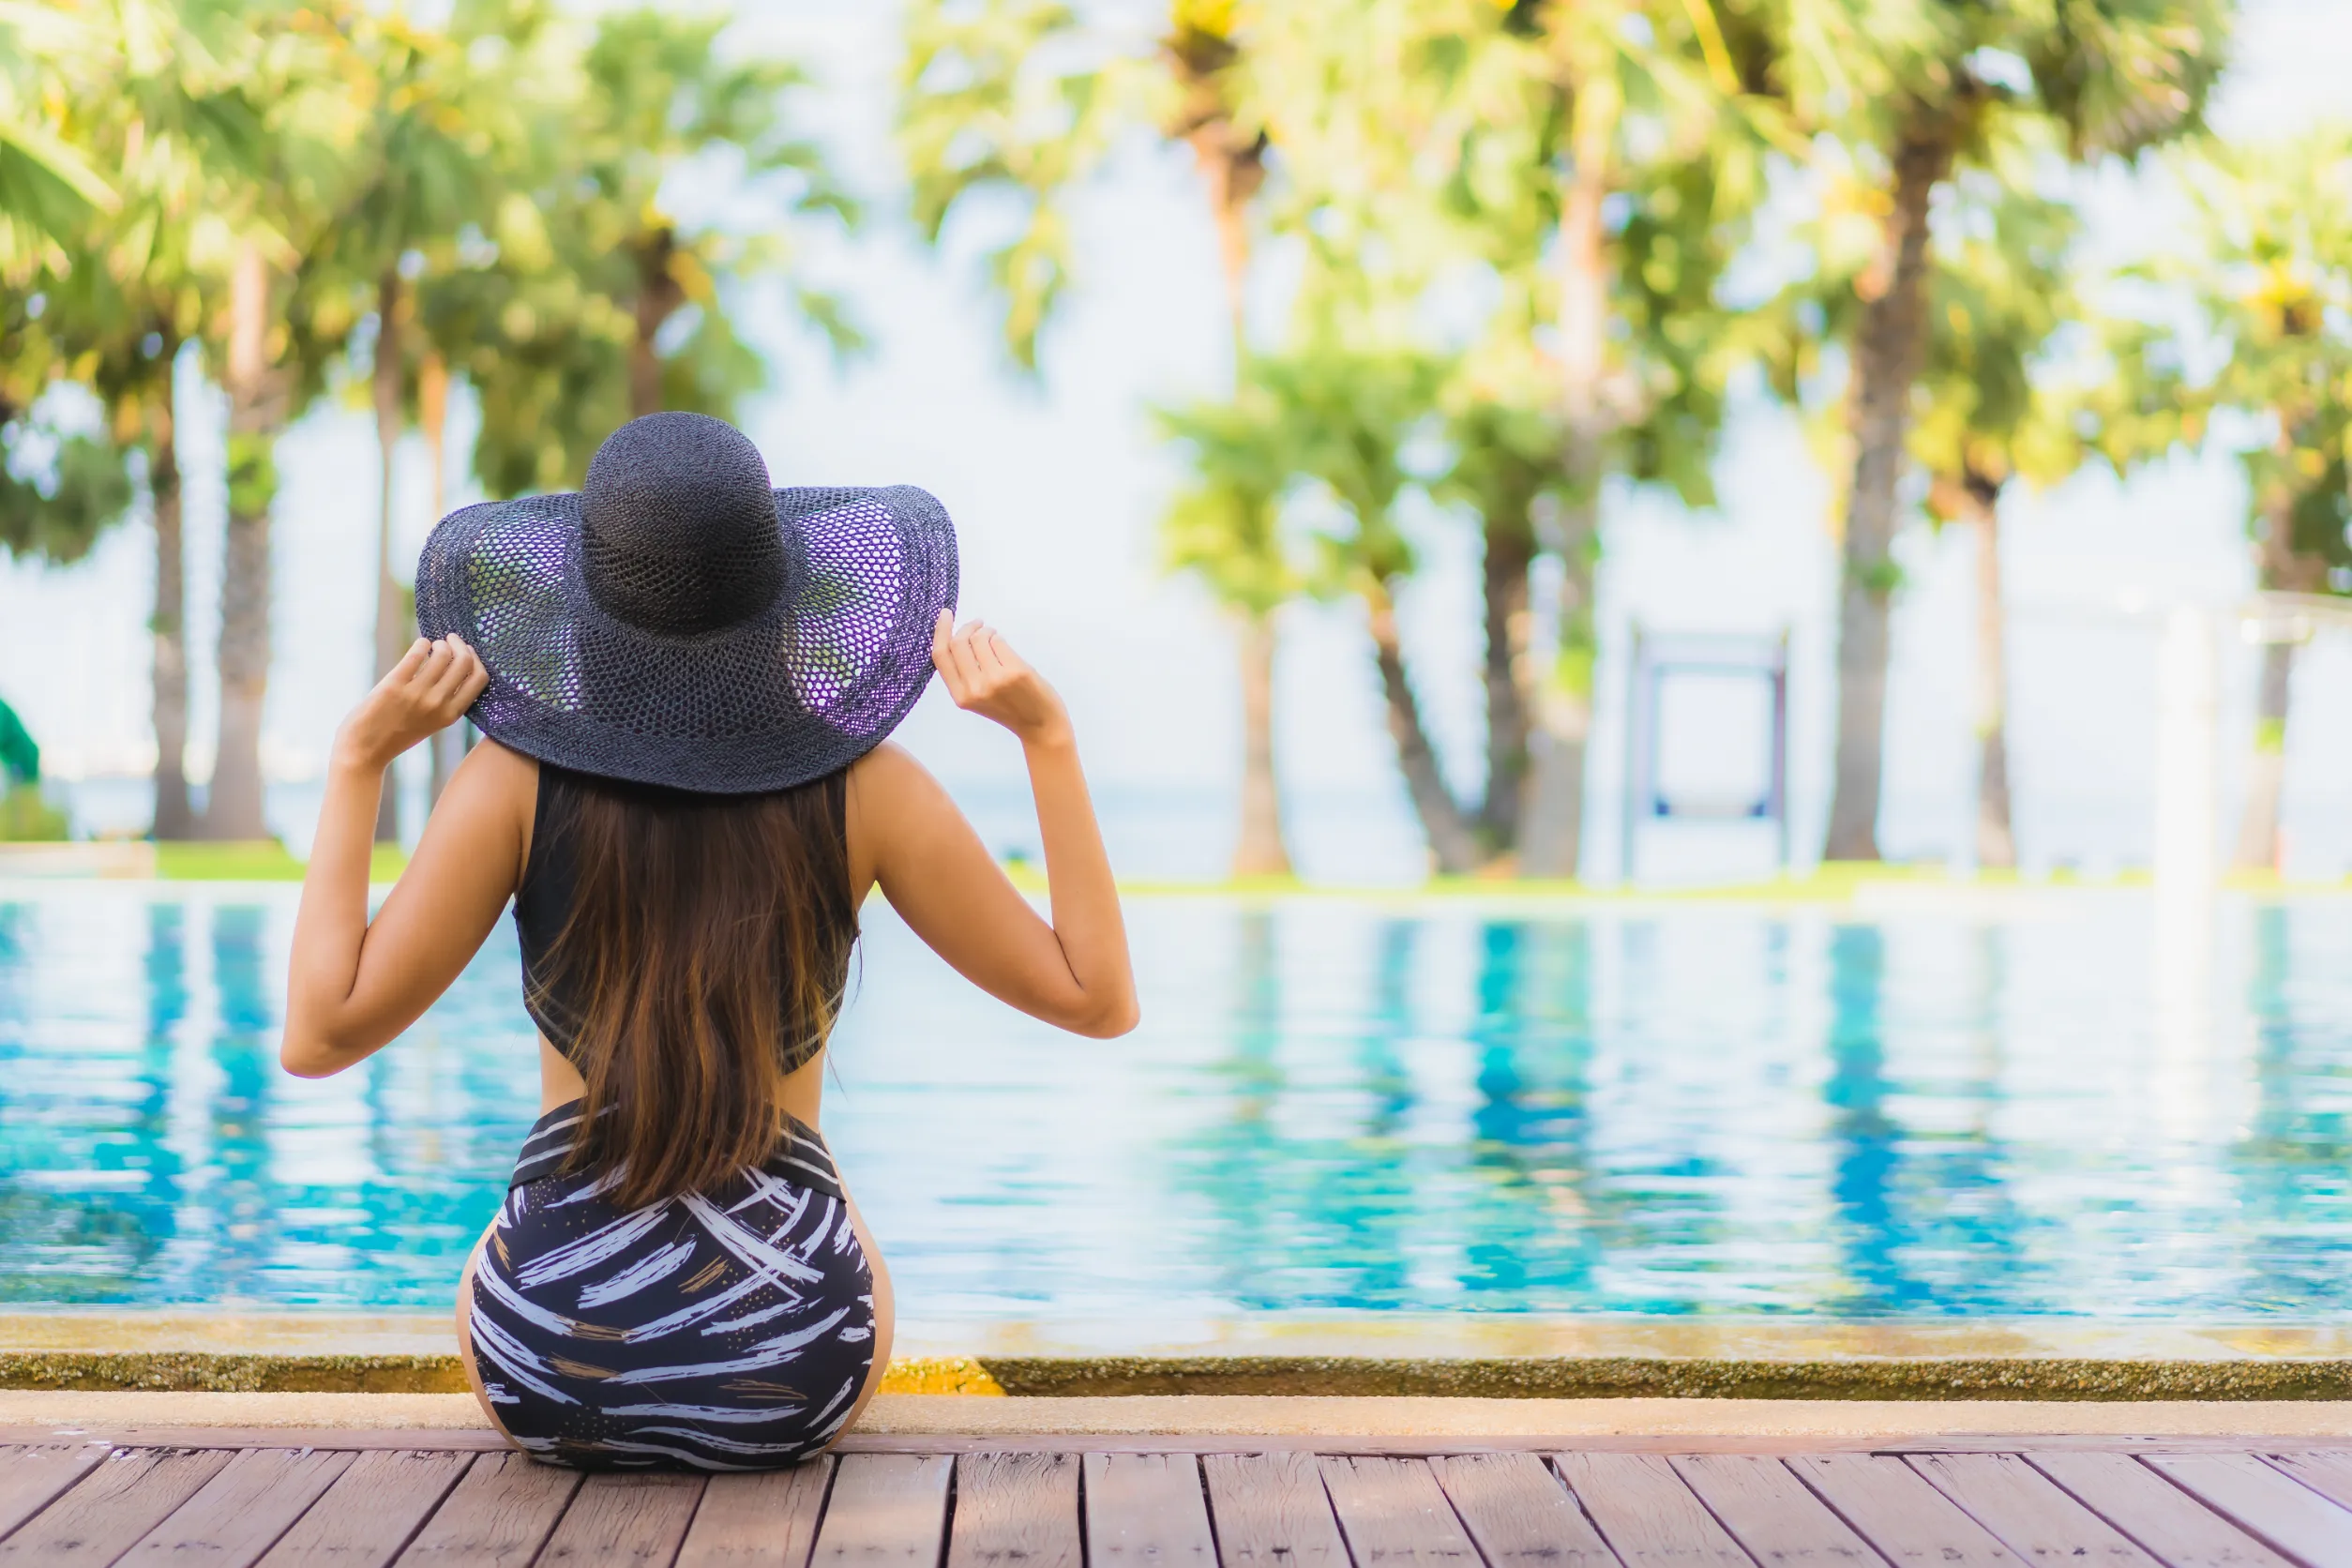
[580,414,786,637]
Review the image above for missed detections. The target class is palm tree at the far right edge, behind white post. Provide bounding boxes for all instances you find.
[2077,125,2352,869]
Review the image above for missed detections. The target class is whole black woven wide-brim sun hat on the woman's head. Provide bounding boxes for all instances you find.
[416,414,957,794]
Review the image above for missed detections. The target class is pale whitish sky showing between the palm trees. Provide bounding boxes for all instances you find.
[0,0,2352,882]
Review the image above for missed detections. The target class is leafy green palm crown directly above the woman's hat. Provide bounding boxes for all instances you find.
[416,9,861,496]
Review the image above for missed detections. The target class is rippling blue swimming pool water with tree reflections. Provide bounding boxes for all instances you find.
[0,884,2352,1321]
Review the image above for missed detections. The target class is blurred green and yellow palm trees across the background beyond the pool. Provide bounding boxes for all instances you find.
[0,0,2352,877]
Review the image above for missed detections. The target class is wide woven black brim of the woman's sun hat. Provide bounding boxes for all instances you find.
[416,484,957,794]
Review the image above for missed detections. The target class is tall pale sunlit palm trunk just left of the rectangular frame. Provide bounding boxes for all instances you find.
[1517,66,1623,877]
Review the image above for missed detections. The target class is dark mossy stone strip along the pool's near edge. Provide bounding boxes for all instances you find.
[0,1349,2352,1401]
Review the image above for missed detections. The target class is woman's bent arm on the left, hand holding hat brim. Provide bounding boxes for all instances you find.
[278,637,521,1079]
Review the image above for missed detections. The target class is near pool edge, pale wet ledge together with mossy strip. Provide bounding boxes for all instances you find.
[13,1307,2352,1401]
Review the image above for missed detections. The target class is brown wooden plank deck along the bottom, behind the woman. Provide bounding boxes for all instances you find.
[0,1429,2352,1568]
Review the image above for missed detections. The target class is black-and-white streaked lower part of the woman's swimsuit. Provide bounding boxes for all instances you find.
[468,1103,875,1470]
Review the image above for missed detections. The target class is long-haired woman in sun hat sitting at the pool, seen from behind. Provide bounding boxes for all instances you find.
[279,414,1136,1470]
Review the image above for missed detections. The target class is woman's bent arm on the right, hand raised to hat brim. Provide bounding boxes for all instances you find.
[849,611,1138,1039]
